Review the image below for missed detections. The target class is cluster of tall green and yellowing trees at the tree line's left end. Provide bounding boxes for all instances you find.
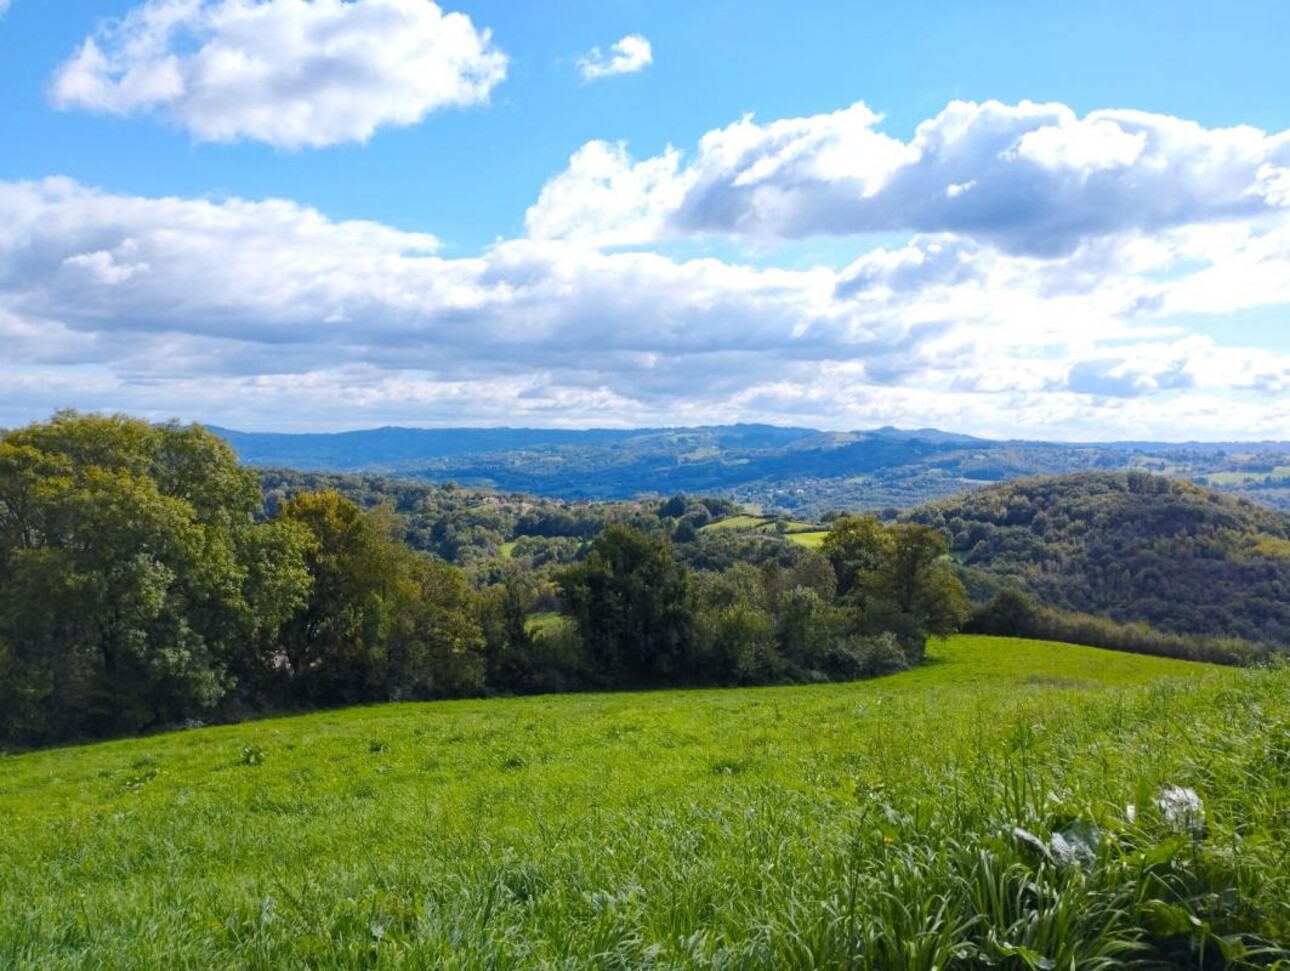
[0,413,482,741]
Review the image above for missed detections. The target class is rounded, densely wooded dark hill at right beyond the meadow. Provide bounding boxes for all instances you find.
[911,473,1290,645]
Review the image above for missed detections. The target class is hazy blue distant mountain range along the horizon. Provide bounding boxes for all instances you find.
[212,424,1290,515]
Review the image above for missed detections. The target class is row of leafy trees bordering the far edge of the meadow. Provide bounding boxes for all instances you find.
[0,411,966,744]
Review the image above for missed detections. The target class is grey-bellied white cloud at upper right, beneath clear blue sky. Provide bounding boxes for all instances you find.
[528,102,1290,257]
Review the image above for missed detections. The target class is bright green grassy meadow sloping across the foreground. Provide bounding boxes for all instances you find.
[0,637,1290,971]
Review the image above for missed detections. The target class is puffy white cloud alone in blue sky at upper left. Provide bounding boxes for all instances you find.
[50,0,507,148]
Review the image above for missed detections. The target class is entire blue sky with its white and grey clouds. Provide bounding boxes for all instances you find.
[0,0,1290,441]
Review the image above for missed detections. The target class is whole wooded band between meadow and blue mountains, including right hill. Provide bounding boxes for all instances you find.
[0,413,1290,744]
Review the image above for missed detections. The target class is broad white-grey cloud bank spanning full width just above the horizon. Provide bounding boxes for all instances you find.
[0,179,1290,438]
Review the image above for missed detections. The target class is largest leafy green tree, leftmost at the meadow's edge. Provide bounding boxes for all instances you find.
[0,411,308,740]
